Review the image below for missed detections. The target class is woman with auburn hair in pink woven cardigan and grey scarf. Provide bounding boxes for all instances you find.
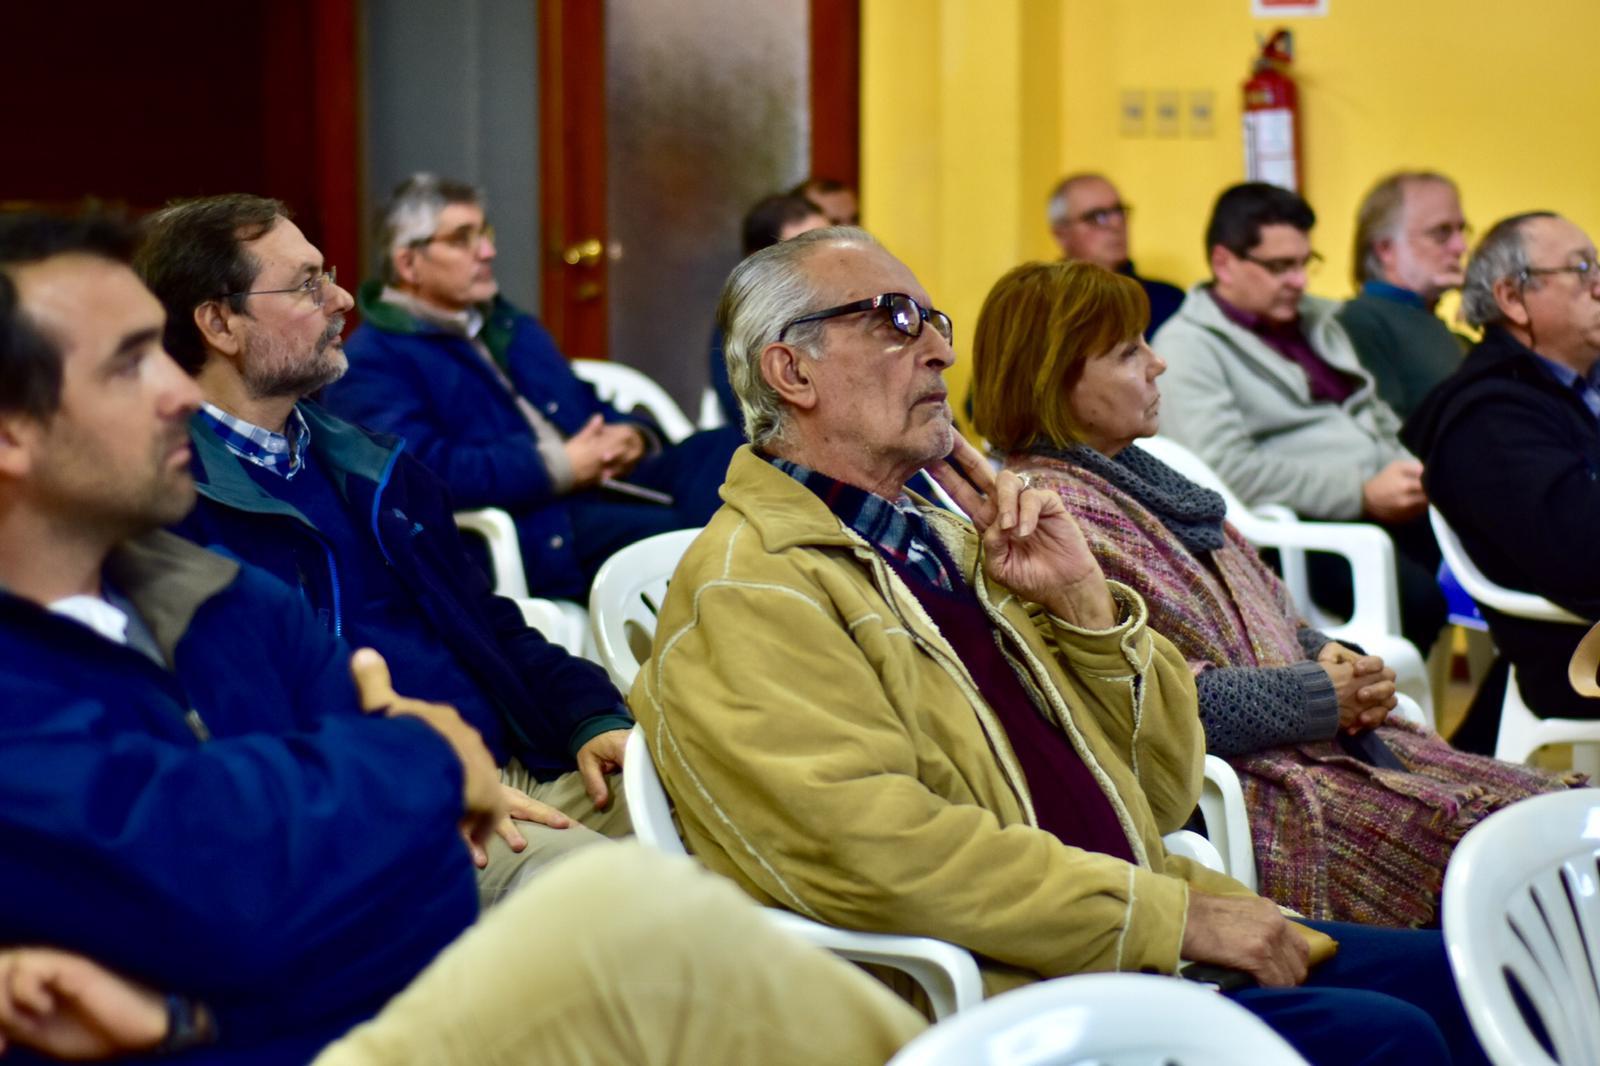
[973,262,1582,925]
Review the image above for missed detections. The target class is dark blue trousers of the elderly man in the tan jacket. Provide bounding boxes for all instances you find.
[1230,922,1488,1066]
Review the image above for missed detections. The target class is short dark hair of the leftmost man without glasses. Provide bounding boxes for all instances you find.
[0,210,138,418]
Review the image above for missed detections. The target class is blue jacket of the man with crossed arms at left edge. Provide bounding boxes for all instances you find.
[0,533,477,1063]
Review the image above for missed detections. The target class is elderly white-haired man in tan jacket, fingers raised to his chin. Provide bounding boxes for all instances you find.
[630,229,1482,1063]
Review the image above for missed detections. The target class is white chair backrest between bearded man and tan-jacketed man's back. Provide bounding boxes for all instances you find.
[589,530,699,693]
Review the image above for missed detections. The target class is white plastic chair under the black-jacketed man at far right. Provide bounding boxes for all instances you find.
[1427,507,1600,771]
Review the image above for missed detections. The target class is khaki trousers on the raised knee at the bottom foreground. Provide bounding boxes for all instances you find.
[315,844,926,1066]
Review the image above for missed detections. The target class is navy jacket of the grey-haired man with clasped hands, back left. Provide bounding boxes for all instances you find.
[323,283,654,589]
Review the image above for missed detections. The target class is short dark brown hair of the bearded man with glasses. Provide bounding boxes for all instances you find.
[133,192,290,375]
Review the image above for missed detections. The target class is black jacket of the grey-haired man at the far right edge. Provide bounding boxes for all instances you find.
[1400,327,1600,717]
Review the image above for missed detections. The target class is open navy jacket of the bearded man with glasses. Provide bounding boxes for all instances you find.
[178,402,632,776]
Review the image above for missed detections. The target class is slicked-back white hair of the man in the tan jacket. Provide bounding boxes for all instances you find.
[717,226,882,448]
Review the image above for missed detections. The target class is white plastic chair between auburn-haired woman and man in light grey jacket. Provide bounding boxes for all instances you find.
[1138,437,1435,728]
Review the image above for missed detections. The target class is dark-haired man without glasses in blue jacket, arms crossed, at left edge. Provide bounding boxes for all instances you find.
[0,209,502,1061]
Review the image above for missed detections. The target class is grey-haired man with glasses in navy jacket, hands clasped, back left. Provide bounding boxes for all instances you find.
[326,174,739,599]
